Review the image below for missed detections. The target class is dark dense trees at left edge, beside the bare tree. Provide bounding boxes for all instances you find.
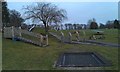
[2,2,25,27]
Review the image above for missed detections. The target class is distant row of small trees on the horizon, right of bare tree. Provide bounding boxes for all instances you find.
[52,18,120,30]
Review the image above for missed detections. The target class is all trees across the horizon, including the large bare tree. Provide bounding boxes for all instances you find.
[2,2,120,32]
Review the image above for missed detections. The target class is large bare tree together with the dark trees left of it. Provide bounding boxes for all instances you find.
[2,2,67,32]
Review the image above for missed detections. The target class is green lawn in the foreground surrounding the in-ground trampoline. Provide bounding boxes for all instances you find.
[2,28,118,70]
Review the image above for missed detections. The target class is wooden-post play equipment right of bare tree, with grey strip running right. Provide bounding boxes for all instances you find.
[49,31,120,47]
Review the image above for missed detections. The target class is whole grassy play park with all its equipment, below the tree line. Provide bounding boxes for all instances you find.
[2,26,120,70]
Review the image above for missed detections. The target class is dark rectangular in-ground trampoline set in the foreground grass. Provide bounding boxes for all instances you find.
[55,52,111,67]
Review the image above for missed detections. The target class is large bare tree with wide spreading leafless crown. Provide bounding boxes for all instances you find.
[24,2,67,32]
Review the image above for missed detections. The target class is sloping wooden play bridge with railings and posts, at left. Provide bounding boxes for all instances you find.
[3,26,48,46]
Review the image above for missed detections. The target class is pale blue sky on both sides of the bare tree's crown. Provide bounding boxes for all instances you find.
[8,2,118,24]
